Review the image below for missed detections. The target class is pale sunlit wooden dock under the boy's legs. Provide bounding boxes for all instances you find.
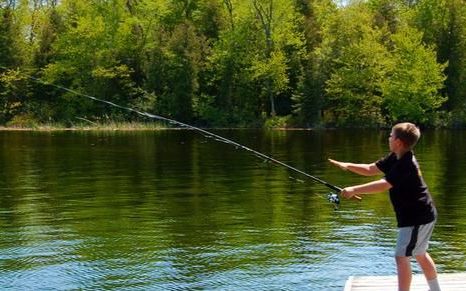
[344,273,466,291]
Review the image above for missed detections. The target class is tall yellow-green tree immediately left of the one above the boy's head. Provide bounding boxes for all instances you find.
[323,3,389,125]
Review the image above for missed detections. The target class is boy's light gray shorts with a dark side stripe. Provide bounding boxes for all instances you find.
[395,221,435,257]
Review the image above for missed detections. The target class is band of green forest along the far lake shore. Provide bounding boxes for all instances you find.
[0,0,466,127]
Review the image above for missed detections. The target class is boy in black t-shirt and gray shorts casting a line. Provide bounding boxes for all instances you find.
[329,122,440,291]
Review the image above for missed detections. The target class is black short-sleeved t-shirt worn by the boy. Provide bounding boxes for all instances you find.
[376,151,437,227]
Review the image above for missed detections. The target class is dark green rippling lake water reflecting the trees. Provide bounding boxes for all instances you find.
[0,130,466,290]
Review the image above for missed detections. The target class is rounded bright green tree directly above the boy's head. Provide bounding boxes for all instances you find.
[382,28,446,124]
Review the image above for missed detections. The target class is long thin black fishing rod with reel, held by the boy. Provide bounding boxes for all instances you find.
[0,65,361,208]
